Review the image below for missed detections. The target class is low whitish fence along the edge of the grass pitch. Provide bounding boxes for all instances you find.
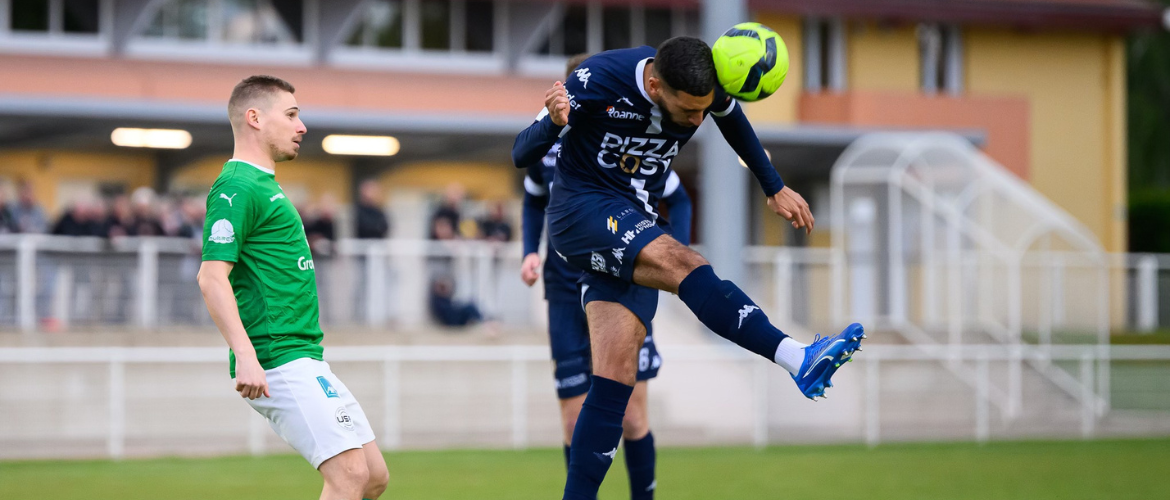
[0,345,1170,458]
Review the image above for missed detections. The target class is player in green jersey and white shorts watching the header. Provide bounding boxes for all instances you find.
[198,76,390,500]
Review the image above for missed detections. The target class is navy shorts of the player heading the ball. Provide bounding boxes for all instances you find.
[549,196,666,283]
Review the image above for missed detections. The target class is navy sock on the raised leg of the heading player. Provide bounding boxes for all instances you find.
[679,266,787,362]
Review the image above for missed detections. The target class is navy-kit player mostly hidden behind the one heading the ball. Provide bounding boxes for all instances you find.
[521,54,691,500]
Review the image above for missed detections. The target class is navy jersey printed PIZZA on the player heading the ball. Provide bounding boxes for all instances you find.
[549,47,736,220]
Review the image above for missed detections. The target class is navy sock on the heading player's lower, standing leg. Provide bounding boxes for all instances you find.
[564,375,634,500]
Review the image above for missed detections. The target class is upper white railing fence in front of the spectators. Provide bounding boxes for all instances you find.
[9,234,1170,343]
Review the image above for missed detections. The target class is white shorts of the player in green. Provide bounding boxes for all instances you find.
[247,357,373,468]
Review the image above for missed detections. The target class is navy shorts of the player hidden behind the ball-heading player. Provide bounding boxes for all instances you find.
[549,299,662,399]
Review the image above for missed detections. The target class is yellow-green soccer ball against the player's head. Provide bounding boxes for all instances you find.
[711,22,789,101]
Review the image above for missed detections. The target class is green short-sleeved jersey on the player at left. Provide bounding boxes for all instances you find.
[204,159,323,377]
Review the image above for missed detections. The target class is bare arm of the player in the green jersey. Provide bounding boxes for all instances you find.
[195,260,269,399]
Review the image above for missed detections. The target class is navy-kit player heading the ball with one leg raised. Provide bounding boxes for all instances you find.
[512,36,863,500]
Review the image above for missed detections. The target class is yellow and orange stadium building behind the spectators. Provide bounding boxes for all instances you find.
[0,0,1159,252]
